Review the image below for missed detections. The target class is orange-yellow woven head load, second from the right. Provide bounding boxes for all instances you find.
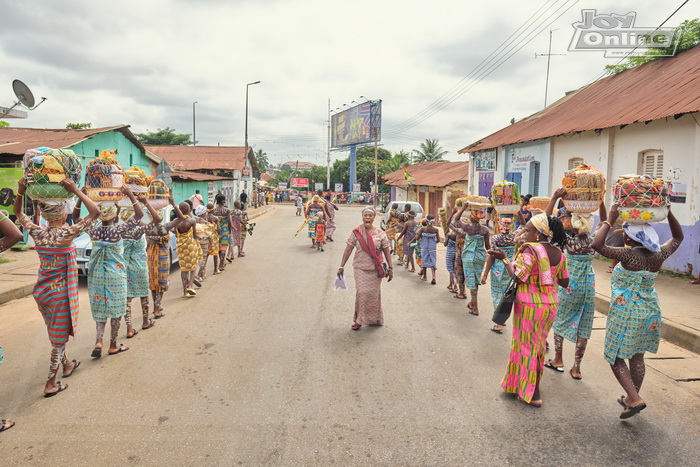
[561,164,605,213]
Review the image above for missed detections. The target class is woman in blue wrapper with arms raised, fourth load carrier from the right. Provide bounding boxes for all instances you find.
[456,203,491,316]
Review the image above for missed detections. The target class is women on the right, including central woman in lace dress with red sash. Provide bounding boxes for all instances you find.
[337,189,683,419]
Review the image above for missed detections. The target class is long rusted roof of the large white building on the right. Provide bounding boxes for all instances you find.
[459,46,700,153]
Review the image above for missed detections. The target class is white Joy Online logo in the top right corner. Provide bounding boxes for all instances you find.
[569,10,677,57]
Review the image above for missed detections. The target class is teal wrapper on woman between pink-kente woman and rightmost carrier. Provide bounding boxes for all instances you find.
[554,255,595,343]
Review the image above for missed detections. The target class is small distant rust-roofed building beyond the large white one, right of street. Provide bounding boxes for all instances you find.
[383,162,469,217]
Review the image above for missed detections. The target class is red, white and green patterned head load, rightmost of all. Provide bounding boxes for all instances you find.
[612,174,670,224]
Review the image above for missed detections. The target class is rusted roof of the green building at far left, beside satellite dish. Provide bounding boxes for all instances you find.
[0,125,145,156]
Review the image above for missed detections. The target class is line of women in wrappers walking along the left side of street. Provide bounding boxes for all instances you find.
[0,178,248,431]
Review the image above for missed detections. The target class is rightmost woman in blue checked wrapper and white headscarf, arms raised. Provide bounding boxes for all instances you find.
[591,204,683,418]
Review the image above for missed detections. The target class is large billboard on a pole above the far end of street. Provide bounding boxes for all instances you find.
[331,100,382,148]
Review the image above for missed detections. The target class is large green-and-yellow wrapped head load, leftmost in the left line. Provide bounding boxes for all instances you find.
[22,147,82,201]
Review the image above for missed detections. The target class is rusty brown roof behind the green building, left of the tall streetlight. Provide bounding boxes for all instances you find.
[146,146,255,170]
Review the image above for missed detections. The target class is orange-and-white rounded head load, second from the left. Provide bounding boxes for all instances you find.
[85,149,124,204]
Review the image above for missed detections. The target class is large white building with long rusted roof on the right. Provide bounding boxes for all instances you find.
[459,46,700,273]
